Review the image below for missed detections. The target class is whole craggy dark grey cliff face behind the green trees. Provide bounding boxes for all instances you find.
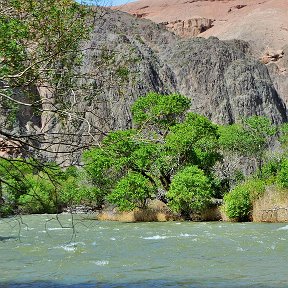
[1,8,287,163]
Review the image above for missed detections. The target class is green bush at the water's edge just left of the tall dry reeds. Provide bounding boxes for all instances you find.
[224,179,265,221]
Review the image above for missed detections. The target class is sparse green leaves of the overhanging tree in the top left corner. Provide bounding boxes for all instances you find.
[0,0,90,93]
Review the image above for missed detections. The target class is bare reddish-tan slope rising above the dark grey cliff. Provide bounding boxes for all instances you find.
[116,0,288,103]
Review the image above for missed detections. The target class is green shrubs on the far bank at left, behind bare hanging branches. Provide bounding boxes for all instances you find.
[0,158,99,214]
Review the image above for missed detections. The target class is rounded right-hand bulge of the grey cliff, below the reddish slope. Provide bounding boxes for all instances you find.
[165,38,286,124]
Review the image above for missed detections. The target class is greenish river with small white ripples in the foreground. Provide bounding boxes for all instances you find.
[0,215,288,288]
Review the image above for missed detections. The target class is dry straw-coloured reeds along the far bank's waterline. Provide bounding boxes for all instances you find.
[95,194,288,223]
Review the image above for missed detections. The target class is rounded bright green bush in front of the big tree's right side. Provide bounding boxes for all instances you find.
[167,166,213,215]
